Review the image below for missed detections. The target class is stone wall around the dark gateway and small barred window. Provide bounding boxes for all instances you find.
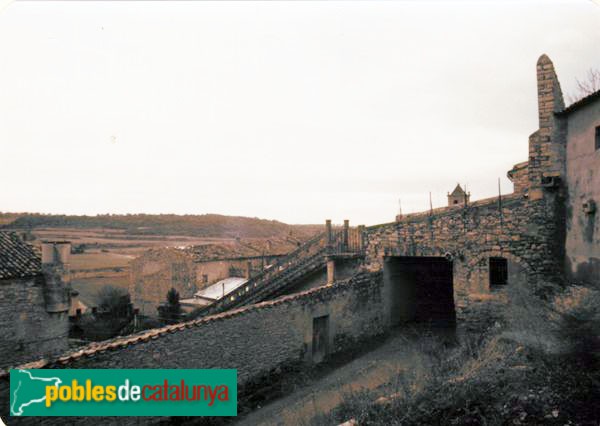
[366,194,560,317]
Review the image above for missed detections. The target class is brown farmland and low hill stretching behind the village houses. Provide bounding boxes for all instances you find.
[0,212,322,307]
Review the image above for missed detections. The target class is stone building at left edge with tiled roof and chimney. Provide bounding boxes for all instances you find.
[0,232,70,368]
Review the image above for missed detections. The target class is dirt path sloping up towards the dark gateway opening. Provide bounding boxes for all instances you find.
[235,331,452,426]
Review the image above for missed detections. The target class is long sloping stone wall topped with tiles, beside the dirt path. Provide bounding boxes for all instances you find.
[0,274,387,424]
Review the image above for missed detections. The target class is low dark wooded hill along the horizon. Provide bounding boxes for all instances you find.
[0,213,324,239]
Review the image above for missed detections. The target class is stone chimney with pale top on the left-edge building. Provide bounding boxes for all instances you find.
[42,241,71,313]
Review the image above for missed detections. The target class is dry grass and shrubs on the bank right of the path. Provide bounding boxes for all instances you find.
[312,286,600,425]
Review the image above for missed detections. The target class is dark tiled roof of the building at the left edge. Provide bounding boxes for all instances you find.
[0,231,42,280]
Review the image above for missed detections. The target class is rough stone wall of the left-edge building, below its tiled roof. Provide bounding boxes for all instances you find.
[0,277,69,368]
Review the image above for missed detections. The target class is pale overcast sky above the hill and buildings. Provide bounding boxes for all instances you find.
[0,0,600,224]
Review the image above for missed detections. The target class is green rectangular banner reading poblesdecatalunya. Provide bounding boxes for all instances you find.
[10,369,237,416]
